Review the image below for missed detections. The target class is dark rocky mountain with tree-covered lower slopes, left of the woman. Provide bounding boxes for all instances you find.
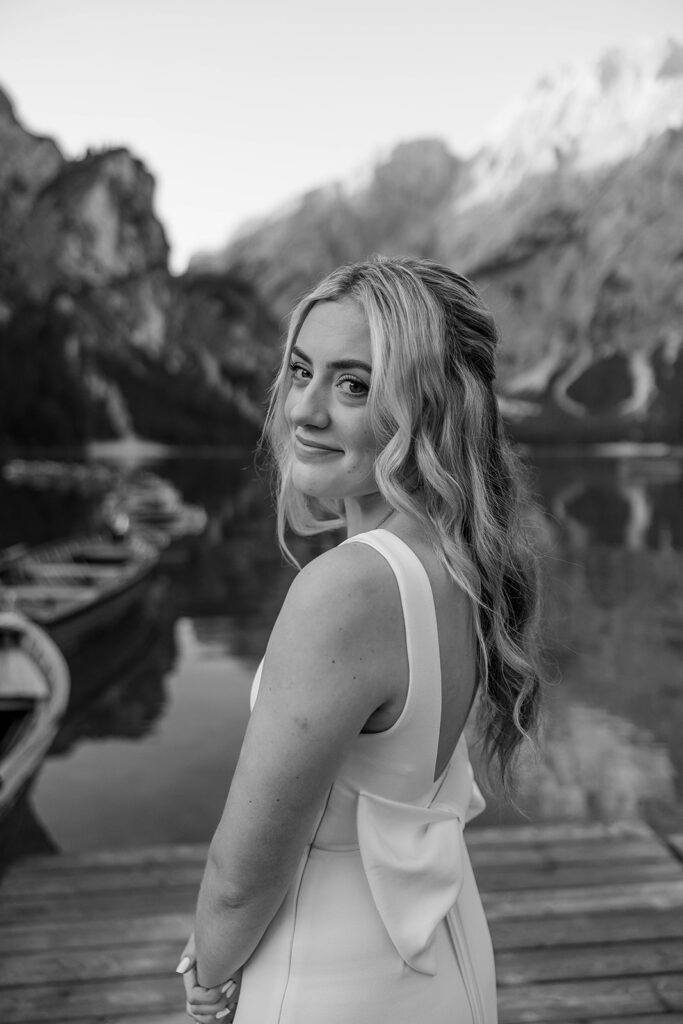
[0,93,278,447]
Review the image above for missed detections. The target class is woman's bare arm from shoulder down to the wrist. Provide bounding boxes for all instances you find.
[195,545,403,986]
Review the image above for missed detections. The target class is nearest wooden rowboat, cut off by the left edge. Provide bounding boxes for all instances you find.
[0,611,70,818]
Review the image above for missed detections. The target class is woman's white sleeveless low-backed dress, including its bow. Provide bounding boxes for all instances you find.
[236,529,498,1024]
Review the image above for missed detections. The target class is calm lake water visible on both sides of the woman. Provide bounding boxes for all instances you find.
[0,452,683,853]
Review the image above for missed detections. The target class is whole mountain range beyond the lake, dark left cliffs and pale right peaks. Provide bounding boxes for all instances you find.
[0,40,683,444]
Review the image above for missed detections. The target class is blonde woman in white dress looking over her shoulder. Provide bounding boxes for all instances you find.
[178,257,539,1024]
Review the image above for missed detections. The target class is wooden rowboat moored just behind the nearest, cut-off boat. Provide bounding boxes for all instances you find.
[0,535,159,653]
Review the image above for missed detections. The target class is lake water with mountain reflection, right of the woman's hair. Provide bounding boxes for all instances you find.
[537,452,683,817]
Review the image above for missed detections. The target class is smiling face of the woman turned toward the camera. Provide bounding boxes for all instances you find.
[285,299,377,499]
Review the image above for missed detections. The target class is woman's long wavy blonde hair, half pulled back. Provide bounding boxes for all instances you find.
[263,256,540,786]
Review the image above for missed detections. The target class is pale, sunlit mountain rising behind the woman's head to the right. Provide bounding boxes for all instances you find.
[190,40,683,443]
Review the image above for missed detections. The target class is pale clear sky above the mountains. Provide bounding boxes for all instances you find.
[0,0,683,271]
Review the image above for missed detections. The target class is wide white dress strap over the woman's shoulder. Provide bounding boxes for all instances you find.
[342,529,441,783]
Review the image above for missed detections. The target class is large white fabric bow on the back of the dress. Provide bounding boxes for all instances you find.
[356,741,485,975]
